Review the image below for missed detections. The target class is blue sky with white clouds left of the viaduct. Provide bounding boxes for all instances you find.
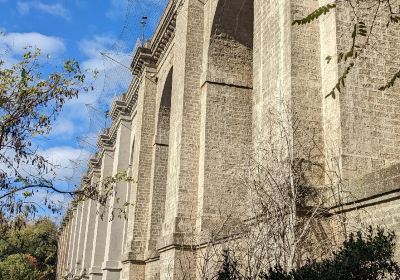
[0,0,167,215]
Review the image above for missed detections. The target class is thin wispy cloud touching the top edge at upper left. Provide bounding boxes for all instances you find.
[17,1,71,20]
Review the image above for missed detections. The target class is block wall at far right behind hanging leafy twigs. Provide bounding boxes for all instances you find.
[321,1,400,178]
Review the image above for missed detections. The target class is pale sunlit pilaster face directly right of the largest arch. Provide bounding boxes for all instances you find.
[253,0,291,145]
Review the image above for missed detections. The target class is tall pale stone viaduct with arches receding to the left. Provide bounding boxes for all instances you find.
[57,0,400,280]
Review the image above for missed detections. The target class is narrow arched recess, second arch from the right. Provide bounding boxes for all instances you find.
[146,68,173,259]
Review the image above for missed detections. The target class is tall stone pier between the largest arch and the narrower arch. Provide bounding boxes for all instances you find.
[158,0,204,279]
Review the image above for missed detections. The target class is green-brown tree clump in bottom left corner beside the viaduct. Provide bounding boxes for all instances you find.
[0,219,57,280]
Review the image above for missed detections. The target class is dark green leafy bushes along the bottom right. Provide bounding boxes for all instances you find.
[217,227,400,280]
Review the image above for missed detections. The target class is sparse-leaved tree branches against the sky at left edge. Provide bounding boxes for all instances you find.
[0,48,94,220]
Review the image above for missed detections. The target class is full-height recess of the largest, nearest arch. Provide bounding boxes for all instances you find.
[197,0,254,231]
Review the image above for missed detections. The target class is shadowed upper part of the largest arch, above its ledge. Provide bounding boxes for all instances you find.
[207,0,254,87]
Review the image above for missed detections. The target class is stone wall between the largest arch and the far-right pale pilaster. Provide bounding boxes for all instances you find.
[252,0,325,184]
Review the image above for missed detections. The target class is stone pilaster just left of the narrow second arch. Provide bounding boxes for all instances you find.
[122,65,157,280]
